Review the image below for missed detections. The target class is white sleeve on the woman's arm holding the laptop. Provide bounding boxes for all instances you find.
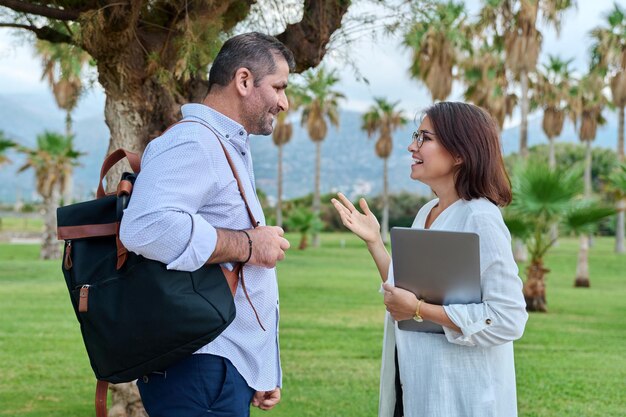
[444,213,528,347]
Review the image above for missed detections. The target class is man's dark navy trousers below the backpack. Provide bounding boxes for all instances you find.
[137,354,255,417]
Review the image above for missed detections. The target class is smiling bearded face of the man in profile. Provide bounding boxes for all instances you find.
[243,57,289,135]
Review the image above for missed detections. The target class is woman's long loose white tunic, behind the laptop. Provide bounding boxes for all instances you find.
[379,199,528,417]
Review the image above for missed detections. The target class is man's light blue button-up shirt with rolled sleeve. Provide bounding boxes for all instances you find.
[120,104,282,391]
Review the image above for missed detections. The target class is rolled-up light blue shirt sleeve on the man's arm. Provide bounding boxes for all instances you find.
[120,129,218,271]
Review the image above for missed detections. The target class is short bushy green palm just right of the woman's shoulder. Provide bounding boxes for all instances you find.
[505,162,614,312]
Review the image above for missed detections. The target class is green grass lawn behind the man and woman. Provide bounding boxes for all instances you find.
[0,234,626,417]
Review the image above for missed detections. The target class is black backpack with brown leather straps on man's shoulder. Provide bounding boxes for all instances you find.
[57,127,257,416]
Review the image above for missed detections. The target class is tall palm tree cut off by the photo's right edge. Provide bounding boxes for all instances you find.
[591,3,626,162]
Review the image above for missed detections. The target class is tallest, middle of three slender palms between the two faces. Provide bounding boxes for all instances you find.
[300,66,344,246]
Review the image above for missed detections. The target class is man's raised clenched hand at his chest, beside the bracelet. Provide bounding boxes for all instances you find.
[246,226,290,268]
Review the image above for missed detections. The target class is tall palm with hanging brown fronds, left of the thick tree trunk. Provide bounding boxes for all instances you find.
[35,40,90,204]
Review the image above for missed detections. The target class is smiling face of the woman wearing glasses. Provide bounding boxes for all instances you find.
[408,116,461,188]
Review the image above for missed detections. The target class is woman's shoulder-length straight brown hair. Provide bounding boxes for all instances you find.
[424,101,512,207]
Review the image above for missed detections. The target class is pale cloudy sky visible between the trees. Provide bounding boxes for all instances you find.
[0,0,613,125]
